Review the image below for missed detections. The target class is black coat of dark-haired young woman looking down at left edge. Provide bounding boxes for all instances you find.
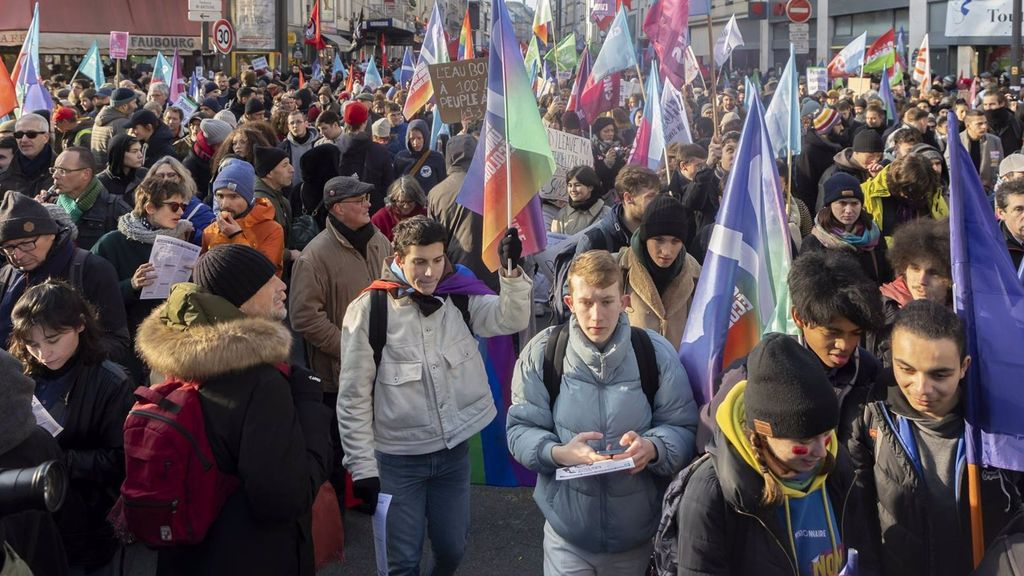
[37,362,133,568]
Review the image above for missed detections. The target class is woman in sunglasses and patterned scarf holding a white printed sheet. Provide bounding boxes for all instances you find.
[92,176,193,383]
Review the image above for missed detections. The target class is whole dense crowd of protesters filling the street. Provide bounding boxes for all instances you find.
[0,51,1024,576]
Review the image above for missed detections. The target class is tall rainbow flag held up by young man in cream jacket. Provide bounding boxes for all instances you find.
[458,0,555,271]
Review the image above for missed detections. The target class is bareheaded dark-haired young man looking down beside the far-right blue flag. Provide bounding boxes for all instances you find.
[850,300,1021,576]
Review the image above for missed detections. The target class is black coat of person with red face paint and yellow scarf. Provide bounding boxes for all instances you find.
[678,424,878,576]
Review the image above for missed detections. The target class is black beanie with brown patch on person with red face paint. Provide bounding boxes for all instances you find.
[743,333,839,440]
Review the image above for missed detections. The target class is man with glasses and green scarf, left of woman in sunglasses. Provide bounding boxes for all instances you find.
[42,147,131,250]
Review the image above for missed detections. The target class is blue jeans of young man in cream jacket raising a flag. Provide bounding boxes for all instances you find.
[376,442,469,576]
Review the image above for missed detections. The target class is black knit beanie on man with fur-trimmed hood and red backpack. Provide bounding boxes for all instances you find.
[193,244,278,306]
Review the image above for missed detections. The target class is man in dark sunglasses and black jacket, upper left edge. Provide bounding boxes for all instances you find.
[0,114,54,197]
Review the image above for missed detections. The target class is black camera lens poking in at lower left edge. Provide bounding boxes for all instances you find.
[0,460,68,518]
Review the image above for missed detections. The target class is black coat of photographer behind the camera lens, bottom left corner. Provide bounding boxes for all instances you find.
[0,426,68,576]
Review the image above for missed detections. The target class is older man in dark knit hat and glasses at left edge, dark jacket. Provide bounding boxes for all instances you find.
[0,190,129,363]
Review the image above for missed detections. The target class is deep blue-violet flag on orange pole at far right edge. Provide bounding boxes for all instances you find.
[948,111,1024,471]
